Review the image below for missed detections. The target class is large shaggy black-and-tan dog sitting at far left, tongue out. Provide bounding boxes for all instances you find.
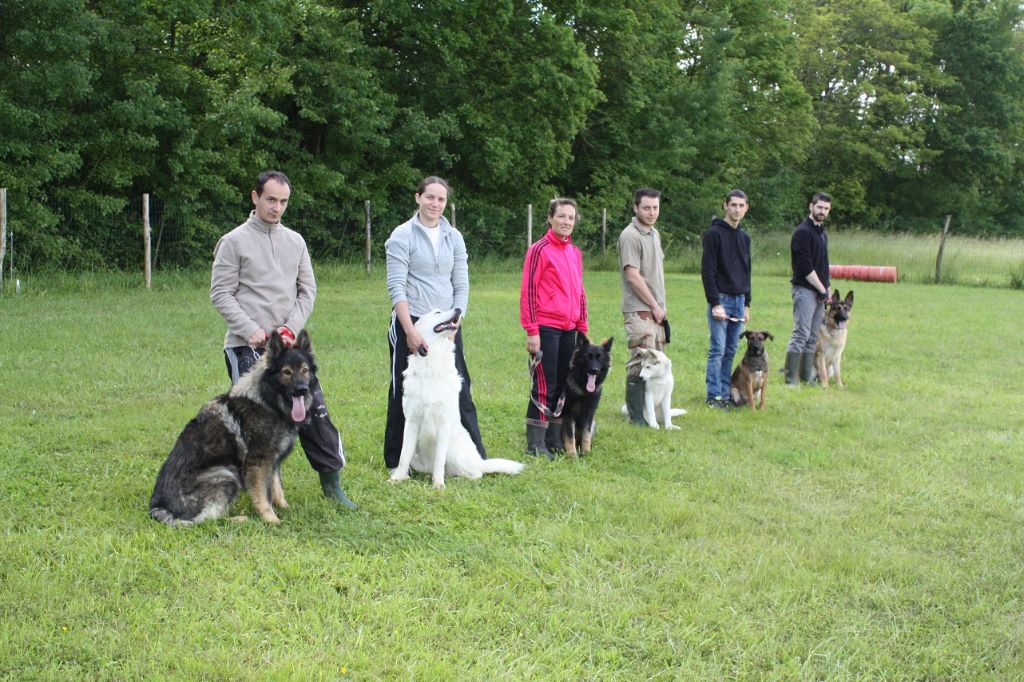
[150,330,316,525]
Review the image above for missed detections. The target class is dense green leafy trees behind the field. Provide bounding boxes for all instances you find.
[0,0,1024,267]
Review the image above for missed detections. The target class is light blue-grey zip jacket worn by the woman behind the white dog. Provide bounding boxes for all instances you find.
[384,212,469,317]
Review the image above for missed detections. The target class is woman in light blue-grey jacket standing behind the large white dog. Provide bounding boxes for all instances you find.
[384,175,486,469]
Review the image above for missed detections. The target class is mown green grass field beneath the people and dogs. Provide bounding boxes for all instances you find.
[0,267,1024,680]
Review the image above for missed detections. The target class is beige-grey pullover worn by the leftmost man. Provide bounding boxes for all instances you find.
[210,211,316,348]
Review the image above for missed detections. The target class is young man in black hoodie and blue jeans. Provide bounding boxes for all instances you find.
[700,189,751,410]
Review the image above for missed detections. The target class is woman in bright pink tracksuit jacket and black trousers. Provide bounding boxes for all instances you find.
[519,199,587,460]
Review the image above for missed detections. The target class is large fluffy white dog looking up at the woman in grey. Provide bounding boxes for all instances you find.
[391,309,523,489]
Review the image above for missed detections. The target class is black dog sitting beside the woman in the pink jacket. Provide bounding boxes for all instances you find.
[562,332,612,457]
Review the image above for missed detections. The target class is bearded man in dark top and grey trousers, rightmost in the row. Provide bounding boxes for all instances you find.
[785,191,831,386]
